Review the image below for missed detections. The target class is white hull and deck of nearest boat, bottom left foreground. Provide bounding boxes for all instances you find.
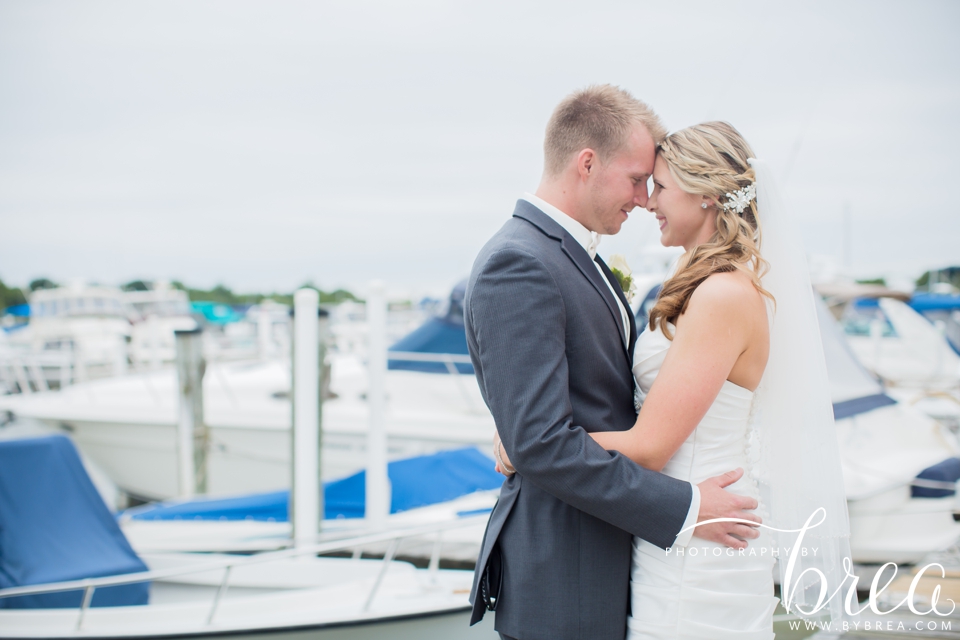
[0,555,498,640]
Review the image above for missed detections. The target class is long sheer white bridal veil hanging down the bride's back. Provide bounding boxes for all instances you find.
[750,158,850,620]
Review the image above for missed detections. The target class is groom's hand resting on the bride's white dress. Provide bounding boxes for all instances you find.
[693,469,761,549]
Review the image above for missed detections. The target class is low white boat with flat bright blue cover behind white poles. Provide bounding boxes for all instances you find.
[117,447,503,563]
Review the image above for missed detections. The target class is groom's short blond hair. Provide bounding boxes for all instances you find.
[543,84,667,177]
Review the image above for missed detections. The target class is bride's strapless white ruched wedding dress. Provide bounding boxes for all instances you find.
[627,328,777,640]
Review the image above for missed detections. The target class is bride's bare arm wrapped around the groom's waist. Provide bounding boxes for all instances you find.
[590,273,766,471]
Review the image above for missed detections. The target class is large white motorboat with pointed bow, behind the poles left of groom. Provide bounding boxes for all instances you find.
[0,284,494,501]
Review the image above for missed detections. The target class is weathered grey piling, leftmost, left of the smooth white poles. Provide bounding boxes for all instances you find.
[174,327,209,498]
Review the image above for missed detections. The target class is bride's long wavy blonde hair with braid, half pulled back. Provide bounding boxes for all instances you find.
[650,122,773,340]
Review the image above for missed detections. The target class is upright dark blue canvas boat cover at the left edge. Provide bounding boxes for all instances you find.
[0,436,150,609]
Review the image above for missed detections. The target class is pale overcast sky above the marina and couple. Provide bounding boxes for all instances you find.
[0,0,960,298]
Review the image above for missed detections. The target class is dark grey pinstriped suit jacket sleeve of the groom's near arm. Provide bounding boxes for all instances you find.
[467,249,692,548]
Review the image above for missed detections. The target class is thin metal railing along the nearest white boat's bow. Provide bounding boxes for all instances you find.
[0,514,488,634]
